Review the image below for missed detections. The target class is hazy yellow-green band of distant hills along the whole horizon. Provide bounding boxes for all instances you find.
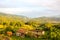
[0,13,60,22]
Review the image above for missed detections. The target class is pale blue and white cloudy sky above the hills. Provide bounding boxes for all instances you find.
[0,0,60,17]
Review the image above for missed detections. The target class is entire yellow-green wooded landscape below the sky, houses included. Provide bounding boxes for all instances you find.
[0,13,60,40]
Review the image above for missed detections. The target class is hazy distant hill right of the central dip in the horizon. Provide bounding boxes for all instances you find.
[31,16,60,23]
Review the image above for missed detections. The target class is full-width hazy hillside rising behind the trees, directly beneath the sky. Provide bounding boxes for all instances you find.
[0,13,60,23]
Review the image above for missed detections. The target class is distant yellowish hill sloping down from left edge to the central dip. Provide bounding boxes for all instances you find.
[0,13,29,22]
